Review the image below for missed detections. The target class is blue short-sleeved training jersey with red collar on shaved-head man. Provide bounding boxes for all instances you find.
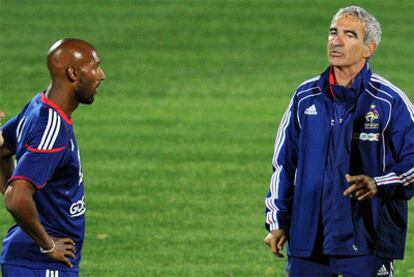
[0,93,86,271]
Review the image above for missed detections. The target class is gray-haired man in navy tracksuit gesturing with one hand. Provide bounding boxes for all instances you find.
[265,6,414,277]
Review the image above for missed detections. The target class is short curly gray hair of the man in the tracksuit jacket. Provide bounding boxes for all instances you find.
[331,6,382,46]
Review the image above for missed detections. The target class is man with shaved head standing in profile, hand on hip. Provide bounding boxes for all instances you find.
[0,39,105,277]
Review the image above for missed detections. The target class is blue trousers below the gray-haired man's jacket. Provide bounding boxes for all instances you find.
[286,255,394,277]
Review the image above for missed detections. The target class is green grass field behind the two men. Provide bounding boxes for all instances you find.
[0,0,414,276]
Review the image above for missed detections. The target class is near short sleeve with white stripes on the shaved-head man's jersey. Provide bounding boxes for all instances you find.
[9,108,68,189]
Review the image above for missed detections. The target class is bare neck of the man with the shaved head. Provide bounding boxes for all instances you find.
[45,81,79,117]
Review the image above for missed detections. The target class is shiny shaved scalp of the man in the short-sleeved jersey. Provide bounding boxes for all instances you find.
[47,38,99,77]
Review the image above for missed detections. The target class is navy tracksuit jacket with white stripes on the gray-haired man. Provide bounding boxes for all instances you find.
[266,63,414,259]
